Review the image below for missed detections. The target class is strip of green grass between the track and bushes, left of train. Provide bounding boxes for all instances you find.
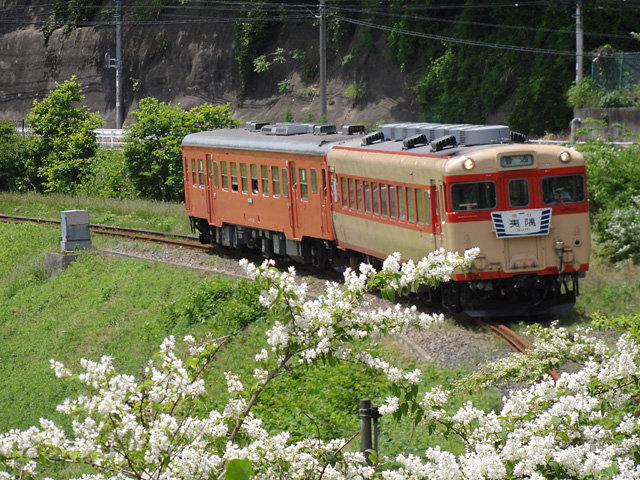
[0,192,191,234]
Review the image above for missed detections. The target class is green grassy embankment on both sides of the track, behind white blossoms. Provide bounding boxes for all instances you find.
[0,194,510,454]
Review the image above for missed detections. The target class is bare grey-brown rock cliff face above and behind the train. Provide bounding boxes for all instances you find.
[0,15,420,128]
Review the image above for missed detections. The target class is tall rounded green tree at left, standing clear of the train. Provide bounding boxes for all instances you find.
[27,76,104,193]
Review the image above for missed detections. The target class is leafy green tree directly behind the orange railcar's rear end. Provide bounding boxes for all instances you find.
[124,97,235,200]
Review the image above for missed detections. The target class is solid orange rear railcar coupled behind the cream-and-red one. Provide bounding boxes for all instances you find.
[182,124,364,266]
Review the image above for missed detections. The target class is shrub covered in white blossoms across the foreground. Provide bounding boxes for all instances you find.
[0,250,640,480]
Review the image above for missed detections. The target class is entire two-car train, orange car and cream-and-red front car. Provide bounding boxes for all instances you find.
[182,121,591,317]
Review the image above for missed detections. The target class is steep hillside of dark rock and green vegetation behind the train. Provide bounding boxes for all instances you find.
[0,0,640,135]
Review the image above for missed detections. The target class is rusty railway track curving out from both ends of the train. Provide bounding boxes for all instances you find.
[0,214,559,380]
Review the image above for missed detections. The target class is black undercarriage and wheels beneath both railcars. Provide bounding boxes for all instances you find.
[190,217,584,317]
